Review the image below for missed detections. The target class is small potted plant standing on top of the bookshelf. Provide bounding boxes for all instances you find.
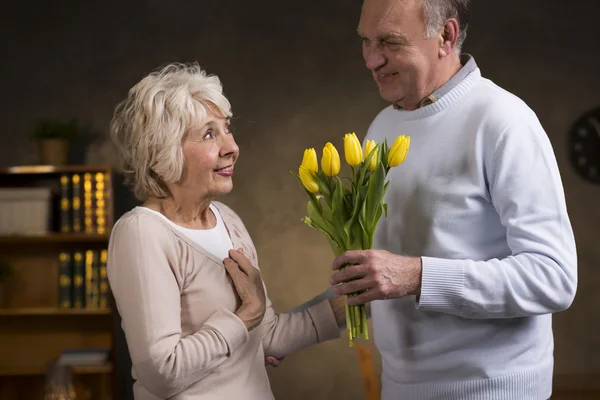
[34,119,81,165]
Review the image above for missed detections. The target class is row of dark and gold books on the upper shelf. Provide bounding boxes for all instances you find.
[60,172,110,234]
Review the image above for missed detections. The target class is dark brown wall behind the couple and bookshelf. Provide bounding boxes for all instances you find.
[0,0,600,400]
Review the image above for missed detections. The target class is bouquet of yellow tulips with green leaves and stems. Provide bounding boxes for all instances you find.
[295,133,410,346]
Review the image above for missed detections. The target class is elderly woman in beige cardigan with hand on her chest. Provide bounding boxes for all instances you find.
[108,64,344,400]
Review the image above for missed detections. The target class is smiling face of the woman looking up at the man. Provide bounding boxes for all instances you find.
[181,113,239,197]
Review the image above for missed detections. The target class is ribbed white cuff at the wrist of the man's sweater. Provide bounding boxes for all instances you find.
[416,257,465,314]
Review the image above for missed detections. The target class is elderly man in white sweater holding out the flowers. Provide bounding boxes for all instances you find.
[330,0,577,400]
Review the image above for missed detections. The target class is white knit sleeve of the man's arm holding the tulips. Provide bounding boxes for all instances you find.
[417,115,577,318]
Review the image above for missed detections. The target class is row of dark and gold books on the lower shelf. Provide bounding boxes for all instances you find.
[58,250,110,309]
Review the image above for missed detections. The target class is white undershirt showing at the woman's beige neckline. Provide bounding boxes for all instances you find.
[139,204,233,260]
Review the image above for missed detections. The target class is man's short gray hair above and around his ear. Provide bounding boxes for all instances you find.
[421,0,469,53]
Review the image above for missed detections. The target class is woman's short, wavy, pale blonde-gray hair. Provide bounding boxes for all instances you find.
[110,63,232,201]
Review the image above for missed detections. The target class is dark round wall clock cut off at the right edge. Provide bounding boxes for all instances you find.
[569,108,600,184]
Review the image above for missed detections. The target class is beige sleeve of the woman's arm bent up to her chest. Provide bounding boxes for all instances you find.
[108,215,248,398]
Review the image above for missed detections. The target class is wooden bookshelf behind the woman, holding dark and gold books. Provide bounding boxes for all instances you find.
[0,165,117,400]
